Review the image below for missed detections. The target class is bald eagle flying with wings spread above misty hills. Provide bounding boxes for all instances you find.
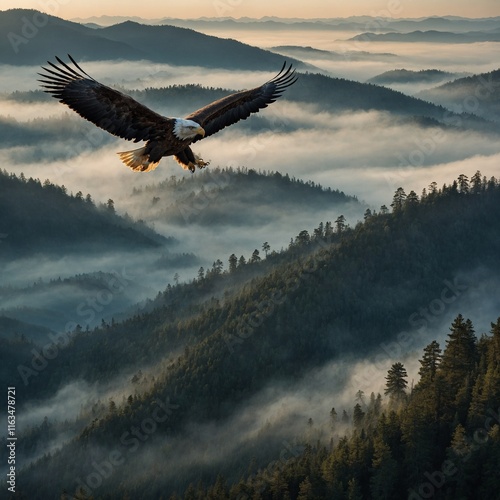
[38,54,297,172]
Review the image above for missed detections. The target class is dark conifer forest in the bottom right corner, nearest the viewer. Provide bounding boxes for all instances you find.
[176,314,500,500]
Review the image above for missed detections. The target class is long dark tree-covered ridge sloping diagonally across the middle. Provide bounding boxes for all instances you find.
[10,173,500,499]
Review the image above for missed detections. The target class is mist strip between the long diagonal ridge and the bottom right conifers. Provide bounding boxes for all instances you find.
[32,268,500,494]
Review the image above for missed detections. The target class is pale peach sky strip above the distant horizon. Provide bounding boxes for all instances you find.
[1,0,500,19]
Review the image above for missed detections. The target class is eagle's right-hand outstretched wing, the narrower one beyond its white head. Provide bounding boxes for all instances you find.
[186,63,297,142]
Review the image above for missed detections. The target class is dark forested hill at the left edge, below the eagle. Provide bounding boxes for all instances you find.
[0,170,168,258]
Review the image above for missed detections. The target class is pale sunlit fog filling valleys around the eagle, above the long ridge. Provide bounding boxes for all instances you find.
[0,30,500,322]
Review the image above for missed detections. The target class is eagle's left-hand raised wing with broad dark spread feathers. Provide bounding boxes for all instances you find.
[39,54,173,142]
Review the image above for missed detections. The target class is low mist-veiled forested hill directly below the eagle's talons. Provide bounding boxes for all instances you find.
[127,167,358,229]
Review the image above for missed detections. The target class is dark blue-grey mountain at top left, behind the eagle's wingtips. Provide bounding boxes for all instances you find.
[0,9,307,70]
